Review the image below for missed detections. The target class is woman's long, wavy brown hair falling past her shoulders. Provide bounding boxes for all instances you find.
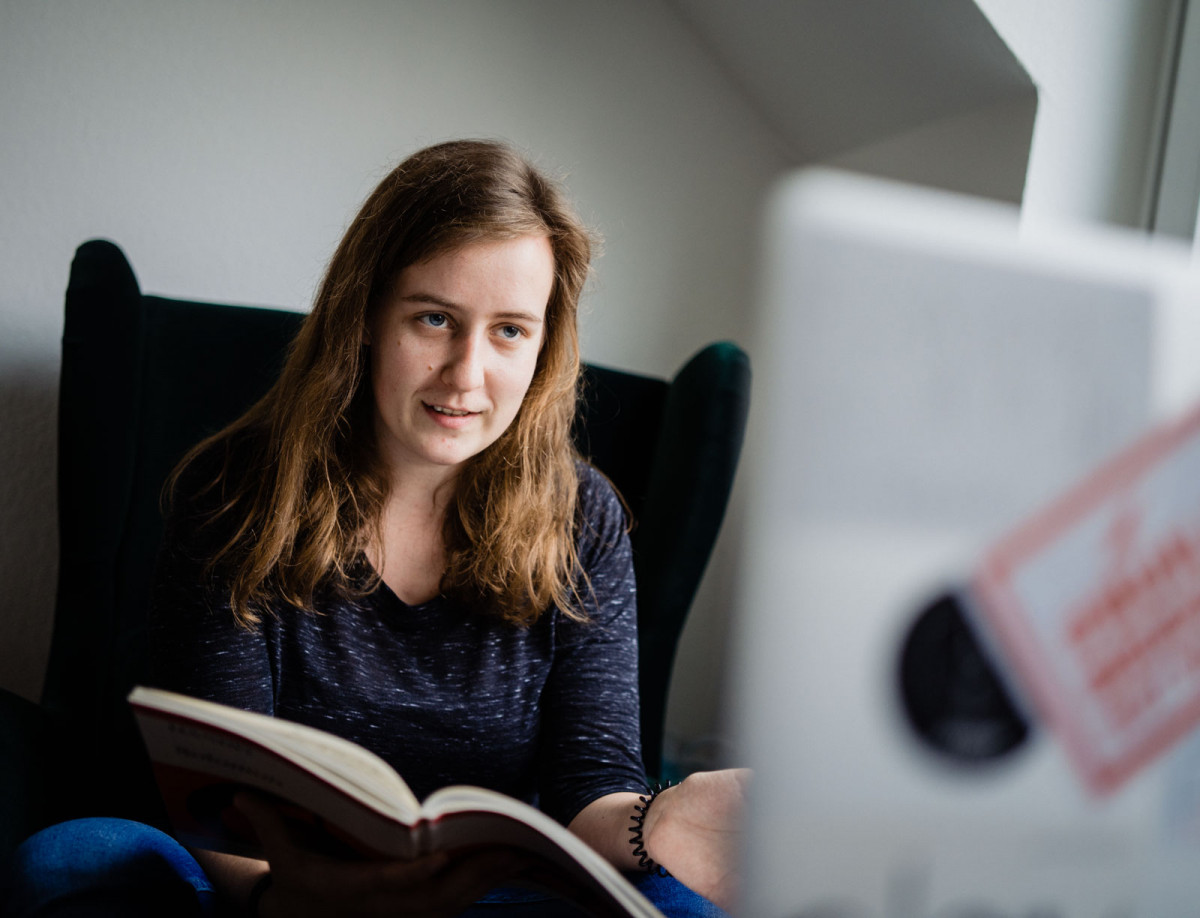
[168,140,592,628]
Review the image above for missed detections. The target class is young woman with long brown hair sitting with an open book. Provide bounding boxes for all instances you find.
[138,142,743,916]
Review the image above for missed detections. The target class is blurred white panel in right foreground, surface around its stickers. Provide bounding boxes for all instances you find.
[732,172,1200,918]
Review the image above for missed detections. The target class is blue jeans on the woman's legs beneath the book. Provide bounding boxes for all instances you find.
[0,818,726,918]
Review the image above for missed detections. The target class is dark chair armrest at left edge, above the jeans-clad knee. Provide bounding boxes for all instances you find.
[0,689,60,860]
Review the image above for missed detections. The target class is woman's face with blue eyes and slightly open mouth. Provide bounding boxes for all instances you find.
[367,236,554,475]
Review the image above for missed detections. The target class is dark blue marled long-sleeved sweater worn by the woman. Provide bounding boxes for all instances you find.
[150,466,644,823]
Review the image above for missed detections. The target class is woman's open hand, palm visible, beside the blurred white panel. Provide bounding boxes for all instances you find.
[642,768,750,908]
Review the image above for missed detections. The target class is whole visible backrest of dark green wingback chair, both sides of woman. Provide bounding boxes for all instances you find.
[43,240,749,818]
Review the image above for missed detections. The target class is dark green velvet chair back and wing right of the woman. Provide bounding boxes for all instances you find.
[575,342,750,779]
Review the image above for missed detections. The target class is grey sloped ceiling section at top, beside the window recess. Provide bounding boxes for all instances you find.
[668,0,1037,163]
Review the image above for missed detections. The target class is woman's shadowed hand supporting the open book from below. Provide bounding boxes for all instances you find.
[234,793,528,918]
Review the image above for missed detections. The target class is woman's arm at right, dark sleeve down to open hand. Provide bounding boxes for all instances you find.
[542,469,745,904]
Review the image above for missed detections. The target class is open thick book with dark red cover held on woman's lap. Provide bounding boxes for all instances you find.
[130,686,661,918]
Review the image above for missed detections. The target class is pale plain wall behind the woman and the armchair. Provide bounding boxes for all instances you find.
[0,0,782,719]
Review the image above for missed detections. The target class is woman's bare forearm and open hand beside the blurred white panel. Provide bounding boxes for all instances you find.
[569,769,749,908]
